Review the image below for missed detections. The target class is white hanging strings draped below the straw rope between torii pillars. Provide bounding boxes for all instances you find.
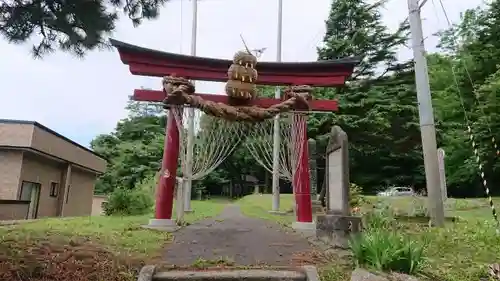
[170,106,306,182]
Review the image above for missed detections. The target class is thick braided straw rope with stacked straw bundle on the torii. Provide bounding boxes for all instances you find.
[163,52,312,122]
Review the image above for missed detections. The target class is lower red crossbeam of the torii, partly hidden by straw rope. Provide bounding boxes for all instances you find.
[133,89,338,112]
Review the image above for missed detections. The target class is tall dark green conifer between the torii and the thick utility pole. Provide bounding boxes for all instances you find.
[309,0,422,191]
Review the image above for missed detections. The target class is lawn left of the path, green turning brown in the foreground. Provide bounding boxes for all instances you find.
[0,200,226,281]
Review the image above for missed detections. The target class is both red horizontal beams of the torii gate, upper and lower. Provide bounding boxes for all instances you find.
[110,39,360,111]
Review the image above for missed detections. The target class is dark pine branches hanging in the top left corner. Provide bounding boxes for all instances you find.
[0,0,168,57]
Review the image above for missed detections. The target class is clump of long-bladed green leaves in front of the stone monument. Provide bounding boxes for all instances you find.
[349,229,425,274]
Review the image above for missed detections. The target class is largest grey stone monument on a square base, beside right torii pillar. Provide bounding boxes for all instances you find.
[316,126,361,248]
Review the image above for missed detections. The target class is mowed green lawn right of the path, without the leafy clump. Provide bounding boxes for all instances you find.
[238,194,500,281]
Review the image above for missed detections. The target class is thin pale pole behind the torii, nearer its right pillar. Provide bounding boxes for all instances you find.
[272,0,283,212]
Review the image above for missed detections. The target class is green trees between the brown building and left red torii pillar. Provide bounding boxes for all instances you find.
[91,101,165,193]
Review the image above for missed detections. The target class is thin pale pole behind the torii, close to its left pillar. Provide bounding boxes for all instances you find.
[181,0,198,212]
